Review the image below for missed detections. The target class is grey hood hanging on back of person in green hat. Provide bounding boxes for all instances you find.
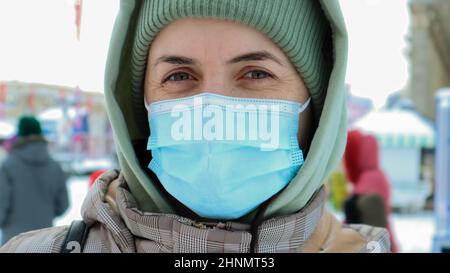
[11,136,51,165]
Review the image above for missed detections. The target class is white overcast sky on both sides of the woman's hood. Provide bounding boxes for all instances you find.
[0,0,409,107]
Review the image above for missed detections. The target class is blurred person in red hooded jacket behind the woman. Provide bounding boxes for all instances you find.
[344,130,399,252]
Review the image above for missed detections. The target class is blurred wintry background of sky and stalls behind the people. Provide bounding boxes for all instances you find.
[0,0,450,252]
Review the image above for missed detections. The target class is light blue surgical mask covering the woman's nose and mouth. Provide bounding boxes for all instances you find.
[147,93,309,220]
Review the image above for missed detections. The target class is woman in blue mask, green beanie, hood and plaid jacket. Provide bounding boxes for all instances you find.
[0,0,390,252]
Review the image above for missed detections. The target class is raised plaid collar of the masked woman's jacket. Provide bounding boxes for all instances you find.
[82,171,325,253]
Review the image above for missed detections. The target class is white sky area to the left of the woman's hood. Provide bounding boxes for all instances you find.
[0,0,118,91]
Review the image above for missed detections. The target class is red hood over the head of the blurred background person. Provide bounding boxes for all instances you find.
[344,130,380,184]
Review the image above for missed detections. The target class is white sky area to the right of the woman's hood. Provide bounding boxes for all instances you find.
[339,0,410,108]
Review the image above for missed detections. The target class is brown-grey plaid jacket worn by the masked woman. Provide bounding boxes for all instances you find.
[0,170,390,253]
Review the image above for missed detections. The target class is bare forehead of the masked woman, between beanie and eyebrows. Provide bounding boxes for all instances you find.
[149,18,286,61]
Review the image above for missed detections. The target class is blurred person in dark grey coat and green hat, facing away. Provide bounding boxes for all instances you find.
[0,116,68,243]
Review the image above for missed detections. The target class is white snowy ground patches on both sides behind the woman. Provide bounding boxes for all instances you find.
[0,176,434,252]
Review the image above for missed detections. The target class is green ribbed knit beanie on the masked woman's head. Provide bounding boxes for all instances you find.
[131,0,333,121]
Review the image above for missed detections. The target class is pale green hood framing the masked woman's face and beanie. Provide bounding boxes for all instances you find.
[104,0,347,222]
